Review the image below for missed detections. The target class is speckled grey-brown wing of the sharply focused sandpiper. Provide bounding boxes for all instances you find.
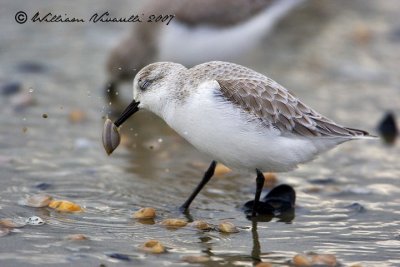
[192,62,369,138]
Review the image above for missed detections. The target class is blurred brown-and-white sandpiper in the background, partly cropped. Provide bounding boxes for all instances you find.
[106,0,304,96]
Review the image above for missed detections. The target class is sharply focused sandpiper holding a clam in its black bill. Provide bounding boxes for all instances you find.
[107,61,373,216]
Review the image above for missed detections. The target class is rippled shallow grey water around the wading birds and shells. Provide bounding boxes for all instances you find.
[0,0,400,266]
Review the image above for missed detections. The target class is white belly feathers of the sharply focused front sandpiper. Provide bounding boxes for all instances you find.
[164,86,318,172]
